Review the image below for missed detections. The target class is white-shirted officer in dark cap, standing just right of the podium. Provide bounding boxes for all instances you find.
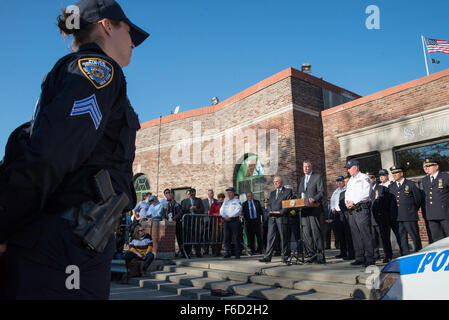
[345,159,375,267]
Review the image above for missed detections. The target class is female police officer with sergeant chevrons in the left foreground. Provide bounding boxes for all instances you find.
[0,0,149,299]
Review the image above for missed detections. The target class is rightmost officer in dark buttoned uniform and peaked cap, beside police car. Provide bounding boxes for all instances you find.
[421,158,449,241]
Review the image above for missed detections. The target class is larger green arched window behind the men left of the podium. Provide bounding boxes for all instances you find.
[235,154,265,201]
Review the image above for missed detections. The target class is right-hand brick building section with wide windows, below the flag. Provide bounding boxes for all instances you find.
[321,69,449,242]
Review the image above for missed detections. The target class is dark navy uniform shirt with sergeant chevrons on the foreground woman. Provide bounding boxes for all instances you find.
[0,43,140,243]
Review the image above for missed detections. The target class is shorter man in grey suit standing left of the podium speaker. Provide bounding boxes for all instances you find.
[259,177,292,263]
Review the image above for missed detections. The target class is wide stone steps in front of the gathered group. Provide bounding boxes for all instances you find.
[113,251,381,300]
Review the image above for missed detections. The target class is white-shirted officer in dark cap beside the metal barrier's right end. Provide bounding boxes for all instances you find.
[220,187,243,259]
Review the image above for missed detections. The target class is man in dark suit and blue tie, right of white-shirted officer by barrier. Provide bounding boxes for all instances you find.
[242,192,263,255]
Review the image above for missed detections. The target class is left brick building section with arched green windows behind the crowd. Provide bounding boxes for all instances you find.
[133,68,360,200]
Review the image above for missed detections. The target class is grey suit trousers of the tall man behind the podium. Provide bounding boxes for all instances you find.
[301,210,324,261]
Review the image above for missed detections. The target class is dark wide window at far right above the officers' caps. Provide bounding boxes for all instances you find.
[394,141,449,177]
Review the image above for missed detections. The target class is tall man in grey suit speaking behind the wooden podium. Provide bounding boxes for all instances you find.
[298,160,326,263]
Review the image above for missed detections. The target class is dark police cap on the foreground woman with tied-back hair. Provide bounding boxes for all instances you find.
[76,0,149,47]
